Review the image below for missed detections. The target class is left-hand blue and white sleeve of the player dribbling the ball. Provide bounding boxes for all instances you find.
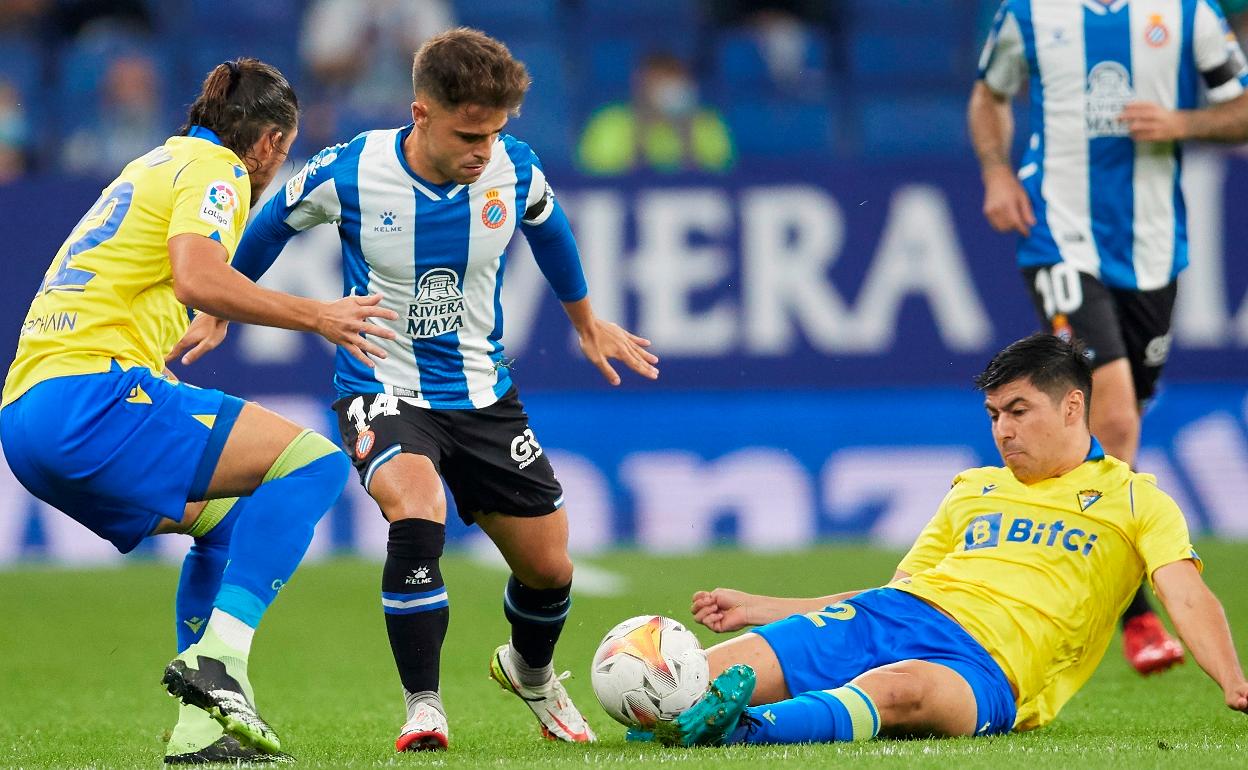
[231,145,344,281]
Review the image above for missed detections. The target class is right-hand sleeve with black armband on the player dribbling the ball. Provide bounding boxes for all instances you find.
[520,162,589,302]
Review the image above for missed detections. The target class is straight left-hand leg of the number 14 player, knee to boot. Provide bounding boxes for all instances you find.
[368,452,451,751]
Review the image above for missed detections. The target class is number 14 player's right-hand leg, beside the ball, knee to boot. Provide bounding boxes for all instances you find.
[473,507,595,743]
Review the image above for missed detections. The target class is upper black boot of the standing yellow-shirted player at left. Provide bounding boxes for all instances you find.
[161,655,282,754]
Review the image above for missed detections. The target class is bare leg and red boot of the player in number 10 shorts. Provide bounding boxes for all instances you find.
[1091,358,1183,674]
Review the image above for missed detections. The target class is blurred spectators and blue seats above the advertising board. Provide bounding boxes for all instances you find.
[0,0,1223,180]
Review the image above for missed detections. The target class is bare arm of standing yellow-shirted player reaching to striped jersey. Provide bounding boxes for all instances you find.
[168,233,398,367]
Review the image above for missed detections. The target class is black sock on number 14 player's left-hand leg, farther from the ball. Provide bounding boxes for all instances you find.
[382,519,451,693]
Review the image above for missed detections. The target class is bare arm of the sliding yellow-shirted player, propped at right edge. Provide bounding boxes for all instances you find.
[1153,559,1248,713]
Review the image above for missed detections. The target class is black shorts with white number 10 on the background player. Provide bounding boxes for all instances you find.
[1022,262,1178,401]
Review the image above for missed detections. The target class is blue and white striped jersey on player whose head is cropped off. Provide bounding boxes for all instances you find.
[980,0,1248,291]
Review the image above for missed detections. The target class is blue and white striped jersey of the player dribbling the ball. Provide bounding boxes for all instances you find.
[235,126,588,409]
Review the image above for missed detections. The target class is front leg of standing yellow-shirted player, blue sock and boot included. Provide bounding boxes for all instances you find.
[157,402,347,754]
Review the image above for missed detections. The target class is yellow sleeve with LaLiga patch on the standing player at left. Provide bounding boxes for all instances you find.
[167,158,251,258]
